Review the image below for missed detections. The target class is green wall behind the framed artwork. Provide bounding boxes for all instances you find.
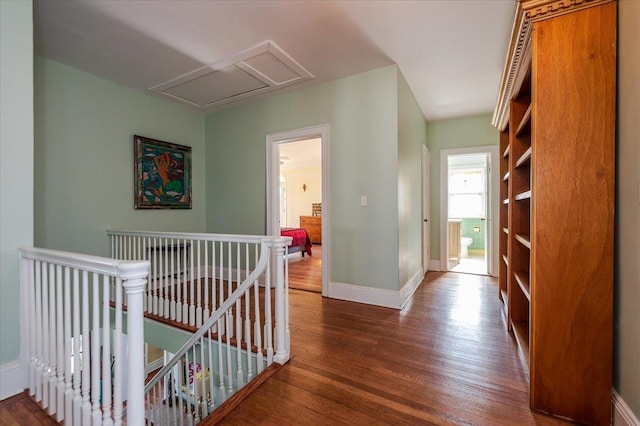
[34,58,205,256]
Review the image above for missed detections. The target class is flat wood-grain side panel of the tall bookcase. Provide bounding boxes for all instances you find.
[530,3,616,424]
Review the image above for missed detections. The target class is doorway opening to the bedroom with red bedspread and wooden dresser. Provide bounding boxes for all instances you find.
[267,125,330,296]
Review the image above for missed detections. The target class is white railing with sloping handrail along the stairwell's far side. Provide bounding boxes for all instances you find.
[108,231,291,425]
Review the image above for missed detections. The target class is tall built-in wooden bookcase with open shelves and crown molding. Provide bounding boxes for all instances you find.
[493,0,616,425]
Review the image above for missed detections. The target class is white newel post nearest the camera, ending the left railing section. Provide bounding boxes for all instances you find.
[119,260,150,425]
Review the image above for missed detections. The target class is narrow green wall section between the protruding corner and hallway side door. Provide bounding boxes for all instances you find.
[397,71,427,287]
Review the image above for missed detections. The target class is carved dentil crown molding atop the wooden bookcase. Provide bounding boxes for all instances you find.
[491,0,616,131]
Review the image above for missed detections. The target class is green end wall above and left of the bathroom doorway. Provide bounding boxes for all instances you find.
[427,114,500,260]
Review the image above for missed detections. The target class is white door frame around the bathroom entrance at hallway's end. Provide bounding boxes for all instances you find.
[440,145,500,277]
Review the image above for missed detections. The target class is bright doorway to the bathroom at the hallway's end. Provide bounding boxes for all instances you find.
[440,147,498,275]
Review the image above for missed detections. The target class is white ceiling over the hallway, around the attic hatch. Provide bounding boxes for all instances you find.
[34,0,515,120]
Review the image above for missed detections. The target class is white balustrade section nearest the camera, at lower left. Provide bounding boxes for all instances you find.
[19,248,149,426]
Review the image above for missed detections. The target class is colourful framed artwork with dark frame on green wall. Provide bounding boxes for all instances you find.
[133,135,191,209]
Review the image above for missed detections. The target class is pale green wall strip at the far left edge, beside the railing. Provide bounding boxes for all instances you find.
[0,1,33,372]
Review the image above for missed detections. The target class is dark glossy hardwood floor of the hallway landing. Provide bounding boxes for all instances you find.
[0,272,567,425]
